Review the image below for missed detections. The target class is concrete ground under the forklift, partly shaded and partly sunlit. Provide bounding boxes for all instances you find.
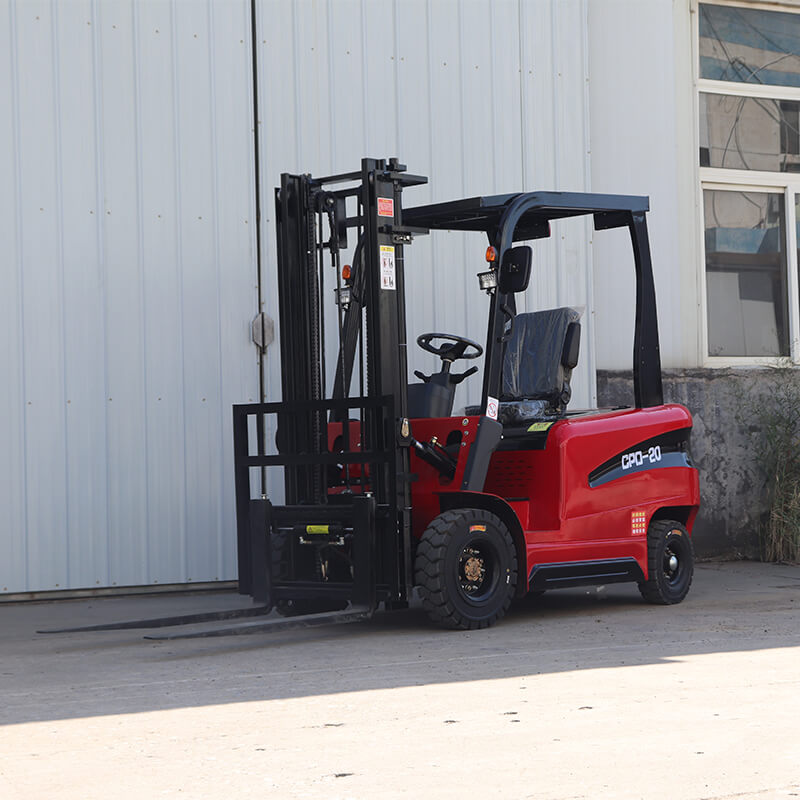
[0,563,800,800]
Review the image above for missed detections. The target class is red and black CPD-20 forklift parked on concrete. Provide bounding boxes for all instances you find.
[40,159,700,638]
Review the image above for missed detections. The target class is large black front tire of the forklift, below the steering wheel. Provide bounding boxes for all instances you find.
[414,508,517,630]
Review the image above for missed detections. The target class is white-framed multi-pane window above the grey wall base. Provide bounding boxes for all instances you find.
[698,0,800,363]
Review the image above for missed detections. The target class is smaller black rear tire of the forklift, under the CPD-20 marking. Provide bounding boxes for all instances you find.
[639,519,694,606]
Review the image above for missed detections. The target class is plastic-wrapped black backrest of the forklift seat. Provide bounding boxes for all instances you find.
[500,307,581,410]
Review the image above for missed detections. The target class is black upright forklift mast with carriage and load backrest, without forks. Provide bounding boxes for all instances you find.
[234,158,427,605]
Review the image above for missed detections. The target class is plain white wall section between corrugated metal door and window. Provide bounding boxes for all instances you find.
[589,0,703,369]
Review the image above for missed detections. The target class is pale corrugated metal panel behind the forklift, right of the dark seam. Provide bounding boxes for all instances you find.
[257,0,595,424]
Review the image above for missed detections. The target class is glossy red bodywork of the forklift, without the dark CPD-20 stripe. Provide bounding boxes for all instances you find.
[411,405,700,579]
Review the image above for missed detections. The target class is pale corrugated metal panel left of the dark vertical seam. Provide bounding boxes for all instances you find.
[0,0,258,592]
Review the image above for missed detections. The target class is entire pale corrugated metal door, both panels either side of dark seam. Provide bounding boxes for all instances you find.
[0,0,594,593]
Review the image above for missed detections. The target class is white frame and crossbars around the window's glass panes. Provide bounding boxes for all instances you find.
[691,0,800,368]
